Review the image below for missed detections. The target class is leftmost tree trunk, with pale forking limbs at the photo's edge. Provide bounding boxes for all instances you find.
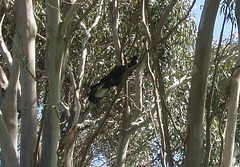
[0,10,19,167]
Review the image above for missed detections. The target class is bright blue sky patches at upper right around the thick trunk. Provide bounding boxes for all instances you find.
[193,0,237,39]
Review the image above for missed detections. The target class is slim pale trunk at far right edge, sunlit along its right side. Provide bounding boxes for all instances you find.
[220,1,240,167]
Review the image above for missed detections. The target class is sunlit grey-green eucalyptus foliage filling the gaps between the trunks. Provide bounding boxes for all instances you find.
[0,0,240,167]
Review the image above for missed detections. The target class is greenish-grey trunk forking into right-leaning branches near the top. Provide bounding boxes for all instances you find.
[40,0,98,167]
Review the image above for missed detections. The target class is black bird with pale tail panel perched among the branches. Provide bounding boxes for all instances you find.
[88,56,138,104]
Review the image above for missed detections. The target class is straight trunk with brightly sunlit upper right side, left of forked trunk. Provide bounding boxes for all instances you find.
[15,0,37,167]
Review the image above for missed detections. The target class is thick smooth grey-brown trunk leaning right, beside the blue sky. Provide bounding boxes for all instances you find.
[185,0,219,167]
